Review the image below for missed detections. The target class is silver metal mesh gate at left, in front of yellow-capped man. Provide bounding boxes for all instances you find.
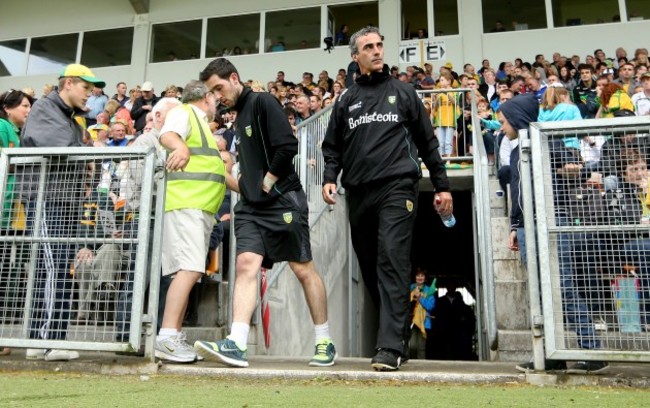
[0,147,164,356]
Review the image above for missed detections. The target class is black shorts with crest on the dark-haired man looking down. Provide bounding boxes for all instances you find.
[235,190,312,268]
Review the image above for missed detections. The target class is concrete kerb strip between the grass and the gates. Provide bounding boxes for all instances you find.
[0,349,650,388]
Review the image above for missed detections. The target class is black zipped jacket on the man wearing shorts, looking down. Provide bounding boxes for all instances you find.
[234,88,302,204]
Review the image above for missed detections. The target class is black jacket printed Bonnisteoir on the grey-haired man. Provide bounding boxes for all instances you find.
[323,65,449,192]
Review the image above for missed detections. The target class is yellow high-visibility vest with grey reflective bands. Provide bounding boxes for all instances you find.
[165,104,226,214]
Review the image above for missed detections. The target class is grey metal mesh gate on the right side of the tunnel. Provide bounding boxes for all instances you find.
[520,117,650,362]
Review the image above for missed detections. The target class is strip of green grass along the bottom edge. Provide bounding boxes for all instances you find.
[0,372,648,408]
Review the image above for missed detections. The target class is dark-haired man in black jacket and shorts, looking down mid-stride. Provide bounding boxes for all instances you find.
[194,58,336,367]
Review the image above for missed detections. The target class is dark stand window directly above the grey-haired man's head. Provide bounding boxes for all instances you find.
[327,1,379,45]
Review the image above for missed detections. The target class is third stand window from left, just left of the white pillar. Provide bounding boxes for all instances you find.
[81,27,133,67]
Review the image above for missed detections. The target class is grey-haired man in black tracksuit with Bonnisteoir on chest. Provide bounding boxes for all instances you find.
[323,27,452,371]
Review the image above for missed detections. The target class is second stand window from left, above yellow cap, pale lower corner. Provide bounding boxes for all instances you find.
[27,33,79,75]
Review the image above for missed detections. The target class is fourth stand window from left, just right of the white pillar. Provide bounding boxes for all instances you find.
[150,20,202,62]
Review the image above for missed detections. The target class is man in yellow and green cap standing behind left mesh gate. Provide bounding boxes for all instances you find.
[17,64,106,361]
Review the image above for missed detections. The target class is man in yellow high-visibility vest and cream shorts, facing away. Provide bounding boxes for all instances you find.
[155,81,235,363]
